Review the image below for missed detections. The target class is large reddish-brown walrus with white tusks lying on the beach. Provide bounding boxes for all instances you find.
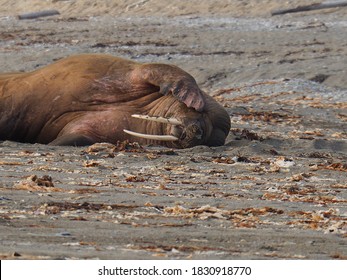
[0,54,230,148]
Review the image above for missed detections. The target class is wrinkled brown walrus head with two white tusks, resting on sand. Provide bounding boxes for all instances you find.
[124,94,230,148]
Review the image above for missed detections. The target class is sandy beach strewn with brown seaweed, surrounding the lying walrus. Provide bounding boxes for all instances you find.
[0,0,347,259]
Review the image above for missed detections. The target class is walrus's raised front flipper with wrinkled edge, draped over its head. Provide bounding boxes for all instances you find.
[136,63,206,112]
